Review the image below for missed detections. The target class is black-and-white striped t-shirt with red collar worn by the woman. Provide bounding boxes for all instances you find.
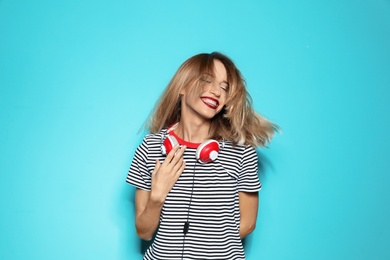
[127,129,261,260]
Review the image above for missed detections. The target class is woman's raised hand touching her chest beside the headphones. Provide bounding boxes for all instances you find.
[150,145,187,203]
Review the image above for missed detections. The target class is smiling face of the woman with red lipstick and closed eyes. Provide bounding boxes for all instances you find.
[181,60,229,120]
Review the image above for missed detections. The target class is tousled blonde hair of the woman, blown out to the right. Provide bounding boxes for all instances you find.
[146,52,278,147]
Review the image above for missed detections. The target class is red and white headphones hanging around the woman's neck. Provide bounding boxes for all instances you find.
[161,135,219,163]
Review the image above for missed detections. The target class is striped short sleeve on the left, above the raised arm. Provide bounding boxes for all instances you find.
[126,139,151,191]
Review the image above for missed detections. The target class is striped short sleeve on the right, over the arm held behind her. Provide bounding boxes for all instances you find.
[237,146,261,192]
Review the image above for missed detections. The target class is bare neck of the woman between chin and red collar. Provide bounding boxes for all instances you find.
[175,119,211,143]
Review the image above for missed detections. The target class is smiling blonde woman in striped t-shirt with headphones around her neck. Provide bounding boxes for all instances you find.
[127,52,277,259]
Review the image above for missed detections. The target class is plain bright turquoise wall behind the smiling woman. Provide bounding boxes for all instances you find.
[0,0,390,260]
